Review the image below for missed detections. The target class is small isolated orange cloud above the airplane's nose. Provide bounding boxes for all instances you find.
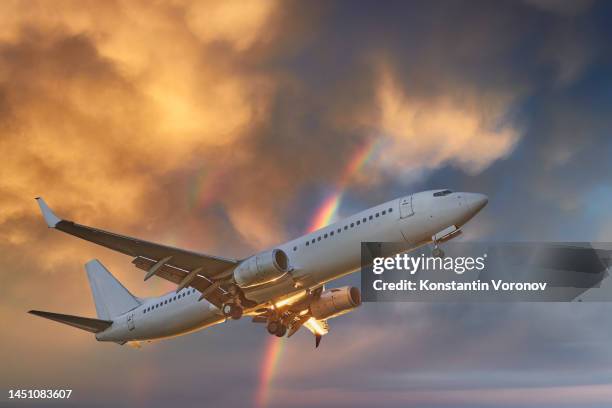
[366,64,519,178]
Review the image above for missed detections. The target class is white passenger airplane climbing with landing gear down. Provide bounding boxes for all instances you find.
[29,189,488,347]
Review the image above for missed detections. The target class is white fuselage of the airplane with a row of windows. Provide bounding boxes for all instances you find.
[96,190,486,342]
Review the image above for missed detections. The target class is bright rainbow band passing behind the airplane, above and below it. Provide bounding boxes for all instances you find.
[255,140,378,408]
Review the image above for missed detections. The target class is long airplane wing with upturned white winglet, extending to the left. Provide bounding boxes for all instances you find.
[36,197,239,306]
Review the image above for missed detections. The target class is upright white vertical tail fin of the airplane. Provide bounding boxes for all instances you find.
[85,259,140,320]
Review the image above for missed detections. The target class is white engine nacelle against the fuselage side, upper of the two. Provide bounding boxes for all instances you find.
[234,249,289,288]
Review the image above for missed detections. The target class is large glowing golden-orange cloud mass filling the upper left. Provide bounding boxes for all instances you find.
[0,2,282,245]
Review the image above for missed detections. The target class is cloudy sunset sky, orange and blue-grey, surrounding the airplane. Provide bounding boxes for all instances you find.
[0,0,612,408]
